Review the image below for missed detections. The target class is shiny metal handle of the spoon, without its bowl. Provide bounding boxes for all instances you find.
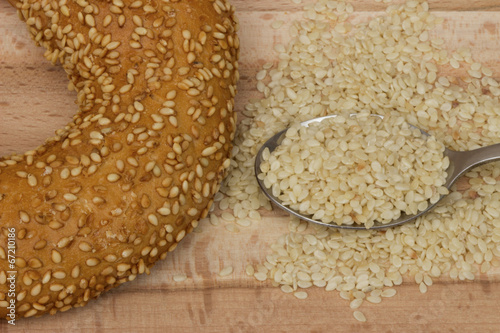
[444,143,500,188]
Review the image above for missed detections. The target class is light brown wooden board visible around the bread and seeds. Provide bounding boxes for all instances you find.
[0,0,500,332]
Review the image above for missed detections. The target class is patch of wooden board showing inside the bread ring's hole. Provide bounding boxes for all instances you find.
[0,17,78,156]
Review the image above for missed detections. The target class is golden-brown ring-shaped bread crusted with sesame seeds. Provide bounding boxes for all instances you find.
[0,0,239,319]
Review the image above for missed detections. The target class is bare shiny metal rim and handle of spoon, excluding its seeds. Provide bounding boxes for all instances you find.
[255,115,500,230]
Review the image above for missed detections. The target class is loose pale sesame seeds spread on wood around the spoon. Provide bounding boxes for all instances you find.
[211,0,500,321]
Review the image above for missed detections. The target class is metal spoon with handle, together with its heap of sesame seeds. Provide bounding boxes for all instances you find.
[255,113,500,229]
